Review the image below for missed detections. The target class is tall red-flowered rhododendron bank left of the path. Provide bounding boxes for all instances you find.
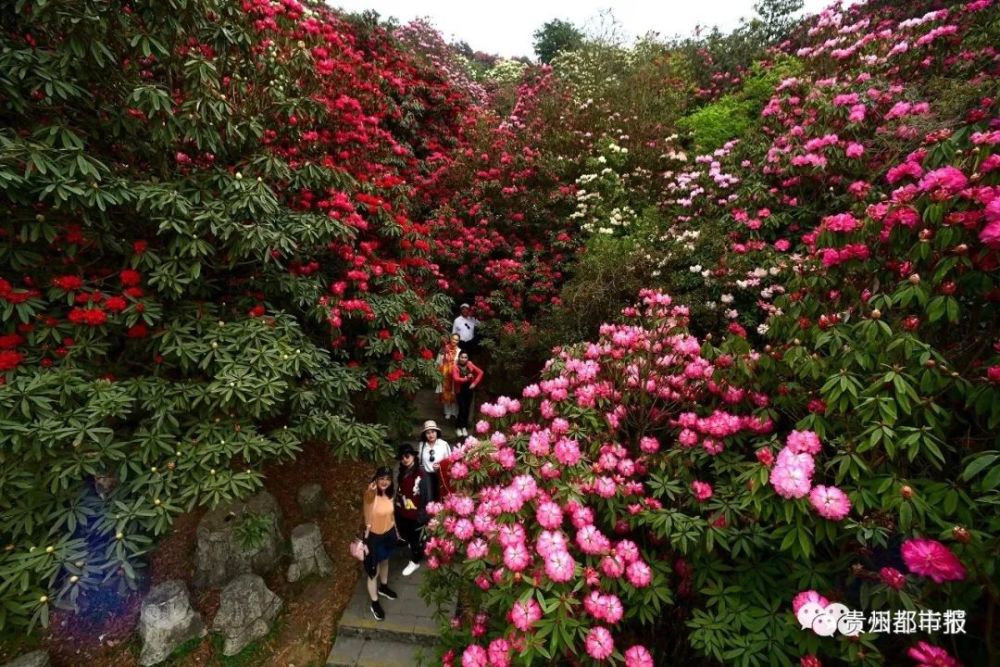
[0,0,472,627]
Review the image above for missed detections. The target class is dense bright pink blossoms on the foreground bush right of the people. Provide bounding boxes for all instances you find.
[427,290,764,667]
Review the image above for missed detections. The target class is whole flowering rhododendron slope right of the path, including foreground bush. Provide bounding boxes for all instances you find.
[422,0,1000,667]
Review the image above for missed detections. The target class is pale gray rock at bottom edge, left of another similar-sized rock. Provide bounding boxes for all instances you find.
[139,580,206,667]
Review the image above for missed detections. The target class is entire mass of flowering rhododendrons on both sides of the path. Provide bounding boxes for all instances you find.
[0,0,1000,667]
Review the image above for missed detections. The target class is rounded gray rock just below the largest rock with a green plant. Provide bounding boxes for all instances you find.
[212,574,284,655]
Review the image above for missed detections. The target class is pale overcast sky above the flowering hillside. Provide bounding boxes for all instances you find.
[326,0,848,57]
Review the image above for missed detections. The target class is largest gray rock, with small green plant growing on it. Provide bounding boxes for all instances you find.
[194,491,284,588]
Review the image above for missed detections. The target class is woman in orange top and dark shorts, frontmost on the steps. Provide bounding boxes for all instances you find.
[362,466,399,621]
